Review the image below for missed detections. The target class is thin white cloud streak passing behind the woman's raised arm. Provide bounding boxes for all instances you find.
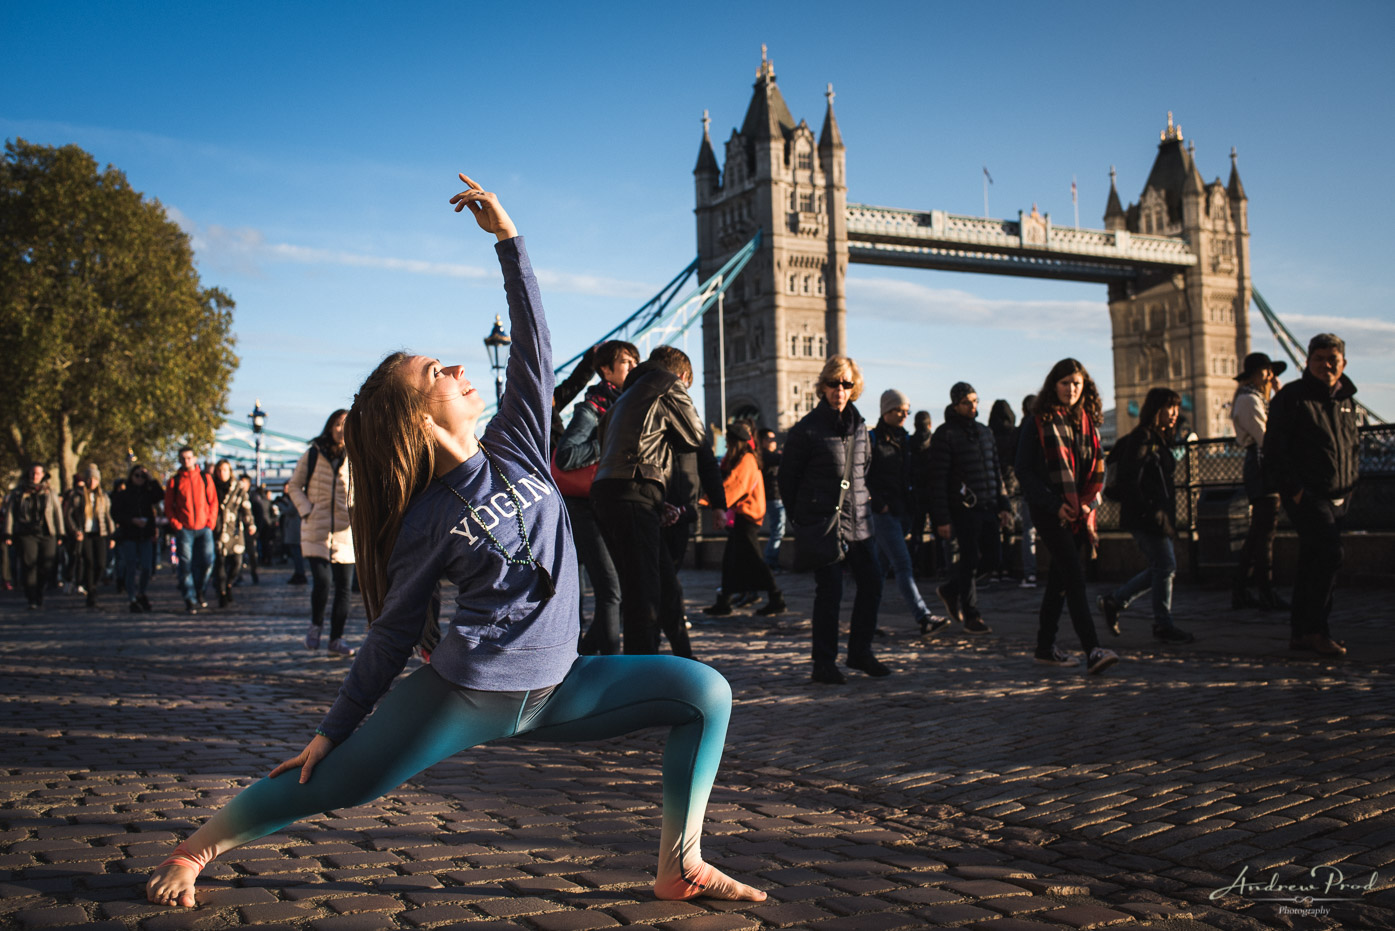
[165,207,657,299]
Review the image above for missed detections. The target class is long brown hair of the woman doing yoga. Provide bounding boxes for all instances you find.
[345,352,435,624]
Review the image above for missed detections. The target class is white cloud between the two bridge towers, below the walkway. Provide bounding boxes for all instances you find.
[848,278,1109,334]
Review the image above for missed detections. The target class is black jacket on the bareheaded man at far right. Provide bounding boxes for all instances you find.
[1264,368,1362,498]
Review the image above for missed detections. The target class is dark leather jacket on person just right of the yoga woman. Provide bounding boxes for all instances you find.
[596,362,704,487]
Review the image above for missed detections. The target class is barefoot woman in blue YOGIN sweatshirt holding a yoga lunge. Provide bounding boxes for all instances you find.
[146,174,766,906]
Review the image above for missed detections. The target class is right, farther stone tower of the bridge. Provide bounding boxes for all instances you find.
[1105,113,1250,437]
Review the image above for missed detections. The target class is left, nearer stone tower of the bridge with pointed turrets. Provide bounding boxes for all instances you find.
[693,46,848,433]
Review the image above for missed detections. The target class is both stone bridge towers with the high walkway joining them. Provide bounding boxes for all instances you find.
[693,50,1250,437]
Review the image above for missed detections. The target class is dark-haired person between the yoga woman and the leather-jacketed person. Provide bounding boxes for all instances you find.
[554,339,639,656]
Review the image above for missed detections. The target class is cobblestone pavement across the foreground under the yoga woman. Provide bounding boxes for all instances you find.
[0,571,1395,931]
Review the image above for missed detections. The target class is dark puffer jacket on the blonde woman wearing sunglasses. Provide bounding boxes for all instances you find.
[780,401,872,543]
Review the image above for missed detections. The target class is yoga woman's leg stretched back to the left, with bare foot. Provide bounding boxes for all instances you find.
[145,666,527,906]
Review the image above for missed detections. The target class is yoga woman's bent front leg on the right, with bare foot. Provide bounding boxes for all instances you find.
[519,656,766,902]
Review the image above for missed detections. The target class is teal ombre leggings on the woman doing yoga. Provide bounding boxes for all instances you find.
[179,656,731,884]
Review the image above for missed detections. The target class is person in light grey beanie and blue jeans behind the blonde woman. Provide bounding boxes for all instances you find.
[868,388,950,636]
